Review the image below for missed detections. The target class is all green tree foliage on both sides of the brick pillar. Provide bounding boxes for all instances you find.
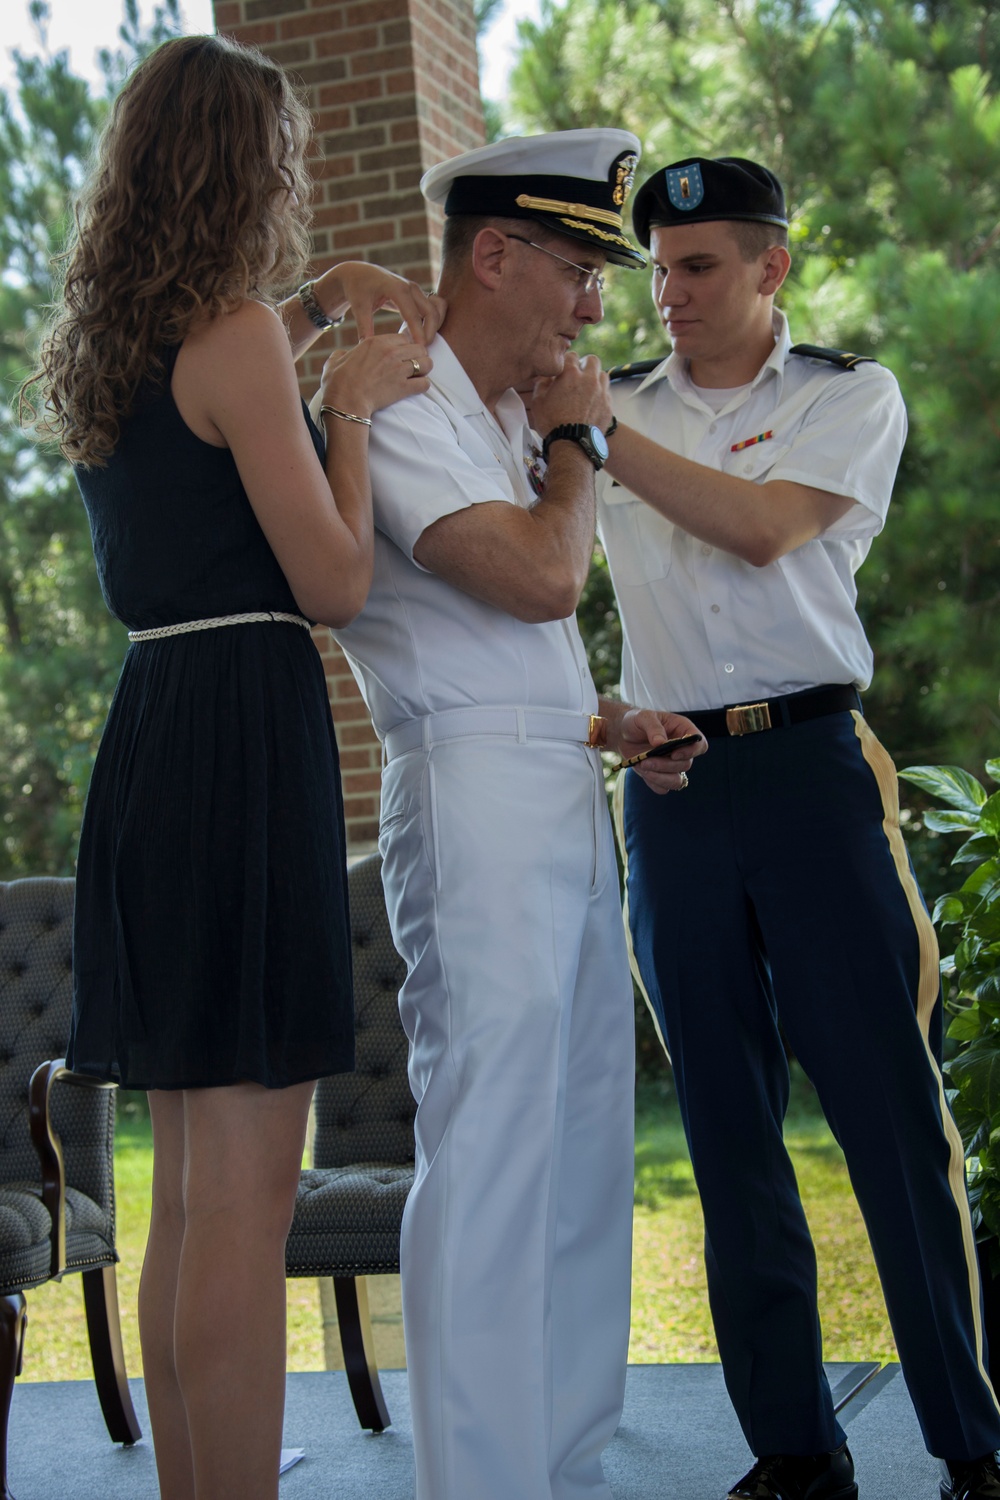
[0,0,1000,876]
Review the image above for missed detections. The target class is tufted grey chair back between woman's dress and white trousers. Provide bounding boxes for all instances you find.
[313,854,415,1167]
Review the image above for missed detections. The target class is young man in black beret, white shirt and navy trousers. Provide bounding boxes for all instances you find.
[598,158,1000,1500]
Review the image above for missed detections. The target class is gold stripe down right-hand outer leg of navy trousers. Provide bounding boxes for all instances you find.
[852,710,1000,1412]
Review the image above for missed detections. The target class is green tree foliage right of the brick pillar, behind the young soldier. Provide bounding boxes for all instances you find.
[507,0,1000,774]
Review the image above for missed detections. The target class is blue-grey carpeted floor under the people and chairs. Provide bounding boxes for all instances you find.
[9,1365,939,1500]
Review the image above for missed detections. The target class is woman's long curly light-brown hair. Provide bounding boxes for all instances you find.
[22,36,310,468]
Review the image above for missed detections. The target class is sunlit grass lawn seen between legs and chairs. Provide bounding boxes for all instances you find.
[22,1079,895,1380]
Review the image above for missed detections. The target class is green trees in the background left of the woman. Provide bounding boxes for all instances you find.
[0,0,180,879]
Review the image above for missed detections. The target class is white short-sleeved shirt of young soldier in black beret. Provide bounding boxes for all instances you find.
[598,312,906,711]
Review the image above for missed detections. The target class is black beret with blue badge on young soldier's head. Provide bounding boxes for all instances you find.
[633,156,789,249]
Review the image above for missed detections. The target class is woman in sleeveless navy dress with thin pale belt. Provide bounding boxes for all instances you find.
[27,38,439,1500]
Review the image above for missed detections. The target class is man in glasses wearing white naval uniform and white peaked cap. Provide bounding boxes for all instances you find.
[327,129,704,1500]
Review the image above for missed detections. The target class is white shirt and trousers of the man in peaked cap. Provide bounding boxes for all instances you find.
[334,338,634,1500]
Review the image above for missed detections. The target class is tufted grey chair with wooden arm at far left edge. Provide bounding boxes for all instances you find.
[0,879,141,1497]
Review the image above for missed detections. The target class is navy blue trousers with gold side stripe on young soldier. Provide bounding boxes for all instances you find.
[624,713,1000,1460]
